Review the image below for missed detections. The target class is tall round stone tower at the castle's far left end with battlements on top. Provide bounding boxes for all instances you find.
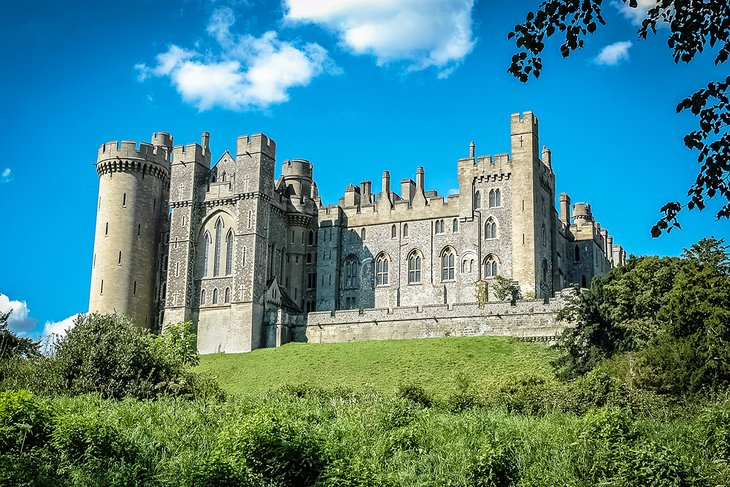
[89,132,172,326]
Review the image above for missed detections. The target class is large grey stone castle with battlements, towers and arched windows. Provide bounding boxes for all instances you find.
[89,112,626,353]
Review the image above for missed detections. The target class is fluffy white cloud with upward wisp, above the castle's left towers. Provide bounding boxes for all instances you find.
[135,7,335,111]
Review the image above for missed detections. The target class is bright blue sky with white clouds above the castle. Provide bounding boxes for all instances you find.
[0,0,730,342]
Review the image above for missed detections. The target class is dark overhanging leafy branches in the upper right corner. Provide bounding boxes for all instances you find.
[508,0,730,237]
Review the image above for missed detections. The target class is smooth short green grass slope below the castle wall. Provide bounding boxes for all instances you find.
[198,337,555,396]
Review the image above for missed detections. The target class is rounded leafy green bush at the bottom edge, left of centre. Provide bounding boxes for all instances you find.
[214,412,327,487]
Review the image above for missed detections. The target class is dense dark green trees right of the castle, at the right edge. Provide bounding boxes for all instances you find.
[557,239,730,396]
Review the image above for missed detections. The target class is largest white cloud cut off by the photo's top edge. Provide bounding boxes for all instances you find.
[284,0,475,77]
